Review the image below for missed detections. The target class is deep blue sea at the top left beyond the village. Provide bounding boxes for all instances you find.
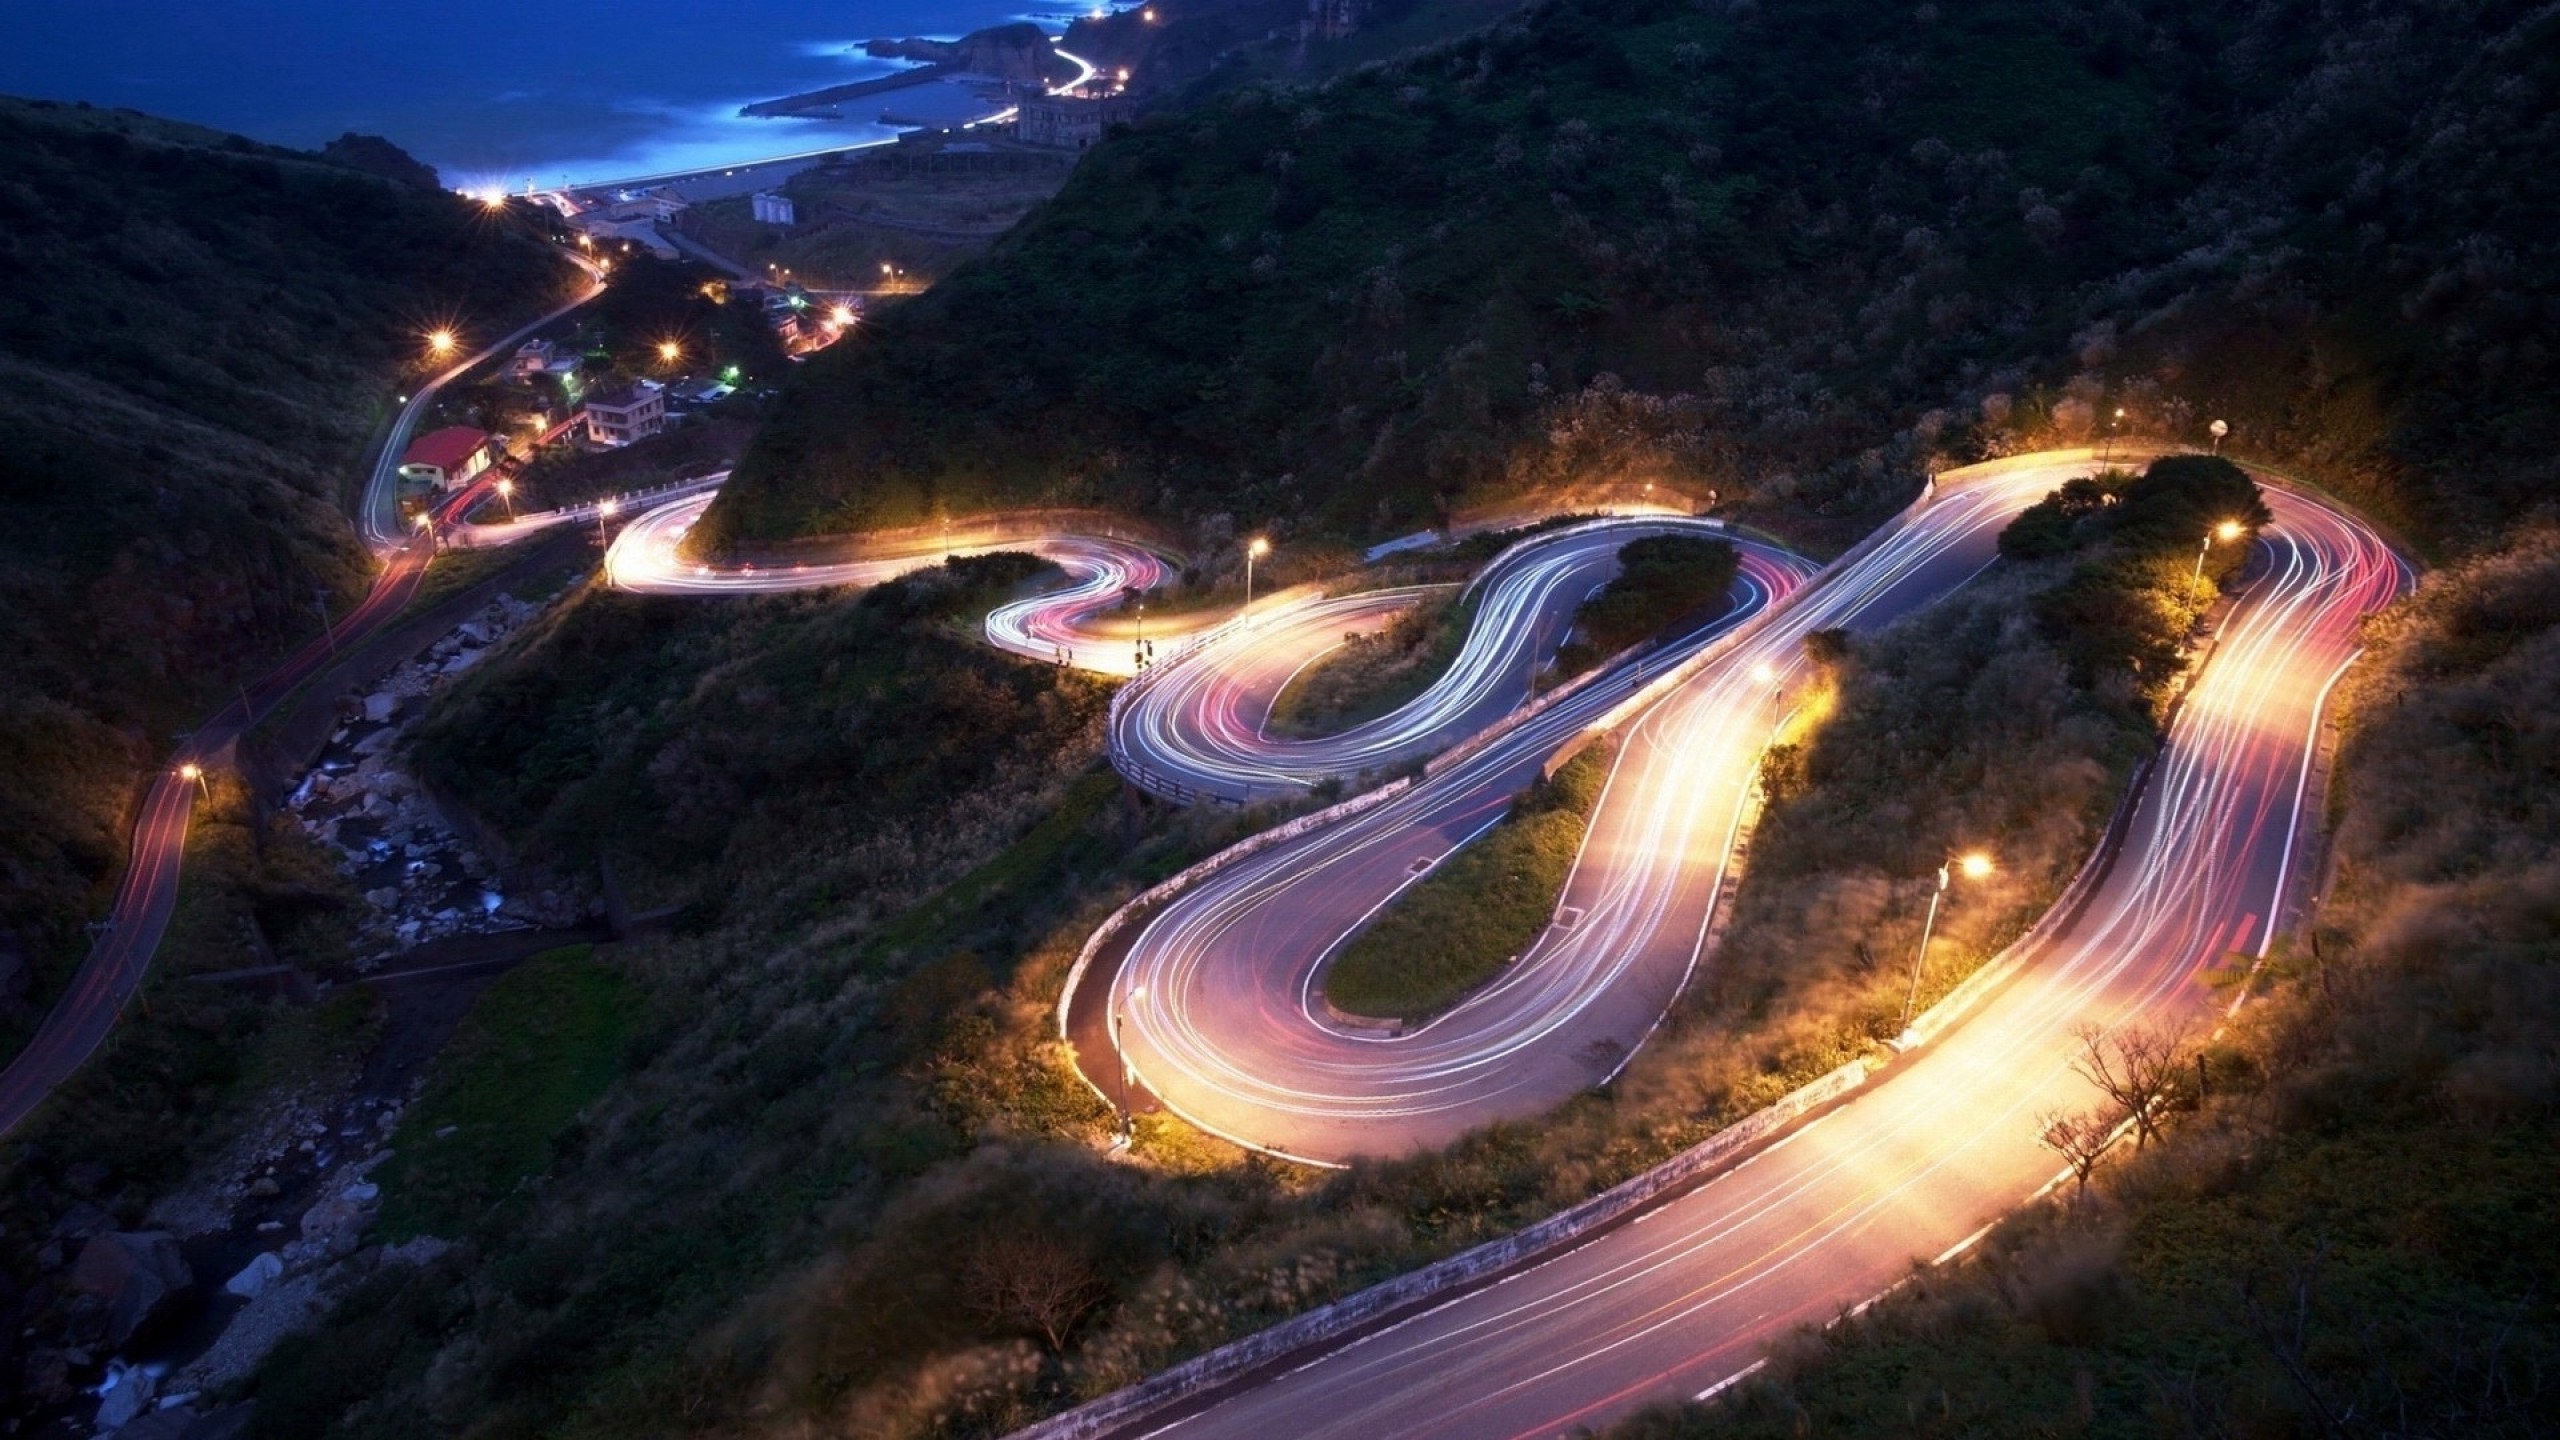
[0,0,1100,190]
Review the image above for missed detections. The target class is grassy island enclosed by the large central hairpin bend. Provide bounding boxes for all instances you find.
[1324,746,1615,1020]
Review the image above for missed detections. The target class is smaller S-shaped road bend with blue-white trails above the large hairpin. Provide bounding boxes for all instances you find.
[1111,518,1810,802]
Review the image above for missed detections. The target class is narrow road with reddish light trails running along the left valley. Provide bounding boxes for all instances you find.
[0,256,602,1135]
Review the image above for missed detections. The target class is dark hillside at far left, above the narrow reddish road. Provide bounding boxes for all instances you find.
[0,100,568,1019]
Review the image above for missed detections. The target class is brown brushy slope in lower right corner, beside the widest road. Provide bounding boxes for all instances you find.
[1620,528,2560,1440]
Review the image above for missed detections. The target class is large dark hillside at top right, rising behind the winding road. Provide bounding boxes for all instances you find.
[701,0,2547,561]
